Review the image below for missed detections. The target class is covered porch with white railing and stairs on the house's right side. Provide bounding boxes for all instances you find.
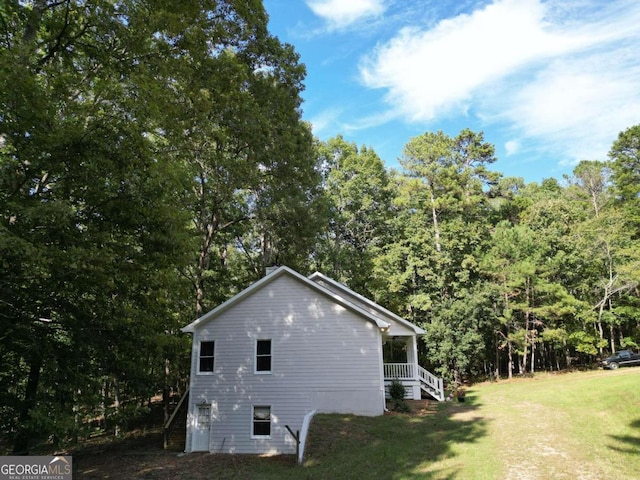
[382,335,444,401]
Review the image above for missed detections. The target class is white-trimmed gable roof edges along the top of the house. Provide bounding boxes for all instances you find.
[181,266,400,333]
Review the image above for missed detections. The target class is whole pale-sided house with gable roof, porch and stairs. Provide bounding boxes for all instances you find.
[182,267,444,453]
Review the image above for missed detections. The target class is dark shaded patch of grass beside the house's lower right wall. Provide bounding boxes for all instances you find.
[300,396,487,479]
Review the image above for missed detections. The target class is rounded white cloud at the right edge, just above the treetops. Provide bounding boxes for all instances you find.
[500,51,640,163]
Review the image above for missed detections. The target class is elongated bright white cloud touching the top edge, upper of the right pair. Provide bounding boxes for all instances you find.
[361,0,580,121]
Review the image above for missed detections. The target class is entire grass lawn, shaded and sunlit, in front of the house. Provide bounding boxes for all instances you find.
[74,368,640,480]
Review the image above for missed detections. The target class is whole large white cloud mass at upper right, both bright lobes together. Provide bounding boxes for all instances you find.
[360,0,640,165]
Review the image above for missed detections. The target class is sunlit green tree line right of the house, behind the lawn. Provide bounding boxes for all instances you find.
[373,125,640,381]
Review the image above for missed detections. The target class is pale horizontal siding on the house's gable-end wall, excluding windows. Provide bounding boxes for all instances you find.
[187,275,384,453]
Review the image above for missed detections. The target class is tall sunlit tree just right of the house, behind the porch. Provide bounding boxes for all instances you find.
[377,129,499,381]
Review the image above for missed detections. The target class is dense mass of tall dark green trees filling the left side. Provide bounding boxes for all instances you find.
[0,0,315,452]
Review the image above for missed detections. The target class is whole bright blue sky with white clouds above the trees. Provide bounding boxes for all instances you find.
[264,0,640,181]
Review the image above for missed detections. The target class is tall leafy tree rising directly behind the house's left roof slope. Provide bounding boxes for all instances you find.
[142,6,320,316]
